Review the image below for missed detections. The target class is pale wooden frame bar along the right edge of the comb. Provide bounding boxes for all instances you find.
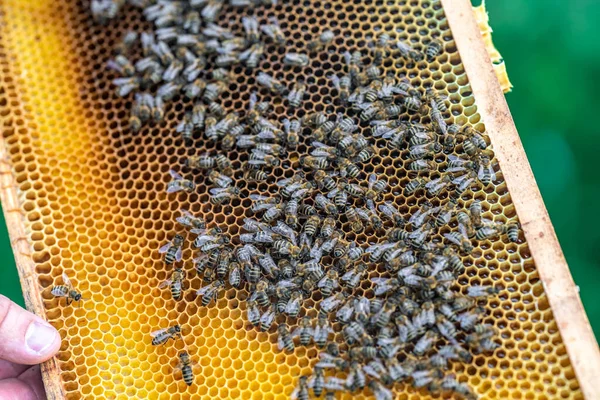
[441,0,600,399]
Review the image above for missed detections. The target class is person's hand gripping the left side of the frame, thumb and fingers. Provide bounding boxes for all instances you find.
[0,295,60,400]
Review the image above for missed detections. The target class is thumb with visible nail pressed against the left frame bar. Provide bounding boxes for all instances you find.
[0,295,60,364]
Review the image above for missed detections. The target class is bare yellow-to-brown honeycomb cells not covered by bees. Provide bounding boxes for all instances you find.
[0,0,582,399]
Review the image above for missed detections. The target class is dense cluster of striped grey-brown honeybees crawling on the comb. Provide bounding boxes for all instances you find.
[39,0,519,399]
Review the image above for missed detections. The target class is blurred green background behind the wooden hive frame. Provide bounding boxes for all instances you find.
[0,0,600,337]
